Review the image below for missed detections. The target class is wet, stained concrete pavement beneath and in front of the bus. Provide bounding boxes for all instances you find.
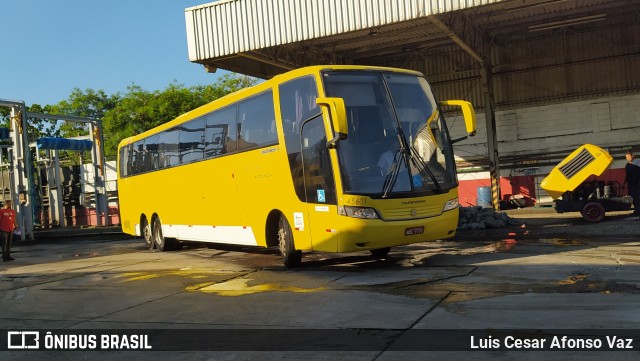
[0,211,640,360]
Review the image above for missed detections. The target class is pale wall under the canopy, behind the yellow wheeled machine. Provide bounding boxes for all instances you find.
[447,95,640,160]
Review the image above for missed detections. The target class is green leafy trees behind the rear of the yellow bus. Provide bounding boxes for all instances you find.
[0,73,258,160]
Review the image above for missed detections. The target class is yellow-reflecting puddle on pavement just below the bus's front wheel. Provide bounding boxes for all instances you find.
[185,278,326,297]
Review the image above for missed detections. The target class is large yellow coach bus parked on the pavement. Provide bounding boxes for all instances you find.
[118,65,475,267]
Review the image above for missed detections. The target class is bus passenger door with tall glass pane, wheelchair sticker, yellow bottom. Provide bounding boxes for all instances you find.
[300,115,338,252]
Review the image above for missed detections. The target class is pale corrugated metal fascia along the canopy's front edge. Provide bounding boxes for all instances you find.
[186,0,500,68]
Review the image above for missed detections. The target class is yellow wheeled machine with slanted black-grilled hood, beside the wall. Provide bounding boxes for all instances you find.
[540,144,631,222]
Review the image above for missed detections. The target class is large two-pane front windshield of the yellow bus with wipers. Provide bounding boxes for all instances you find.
[323,71,457,198]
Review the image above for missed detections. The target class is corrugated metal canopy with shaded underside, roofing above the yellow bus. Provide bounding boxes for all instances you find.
[185,0,640,82]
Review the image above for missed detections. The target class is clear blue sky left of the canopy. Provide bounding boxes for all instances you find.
[0,0,224,106]
